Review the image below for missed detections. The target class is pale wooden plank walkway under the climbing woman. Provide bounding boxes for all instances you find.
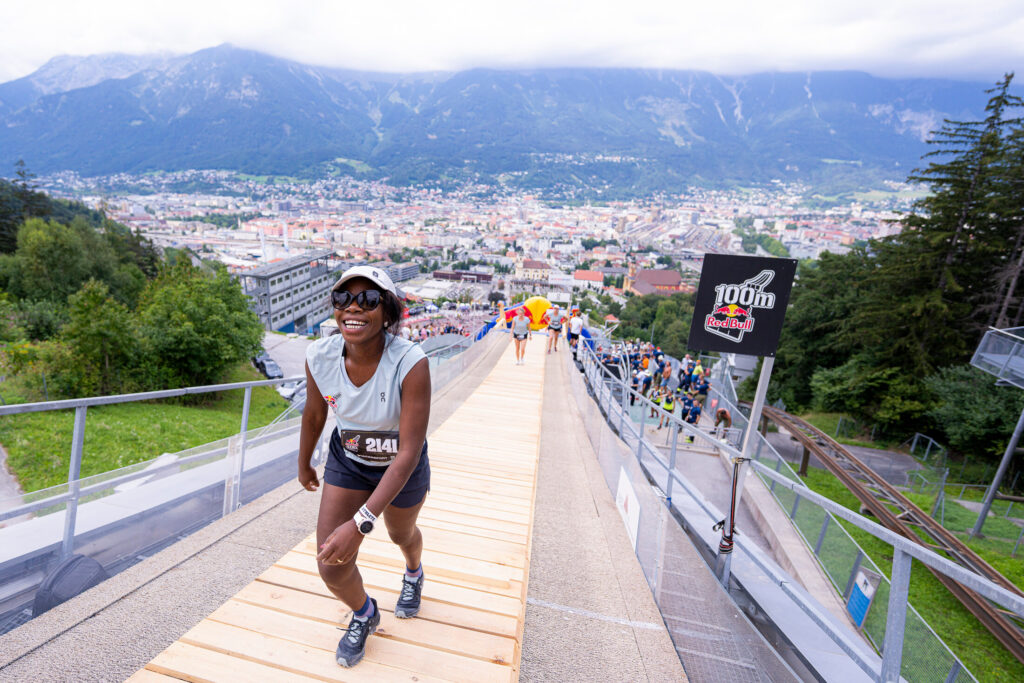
[129,342,546,682]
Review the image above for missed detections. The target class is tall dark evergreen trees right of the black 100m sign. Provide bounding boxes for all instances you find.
[772,74,1024,429]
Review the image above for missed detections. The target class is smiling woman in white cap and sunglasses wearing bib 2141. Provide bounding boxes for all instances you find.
[299,266,430,667]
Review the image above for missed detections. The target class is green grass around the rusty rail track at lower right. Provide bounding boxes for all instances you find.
[798,468,1024,682]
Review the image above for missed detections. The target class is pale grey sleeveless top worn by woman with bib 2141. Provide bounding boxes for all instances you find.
[306,334,427,465]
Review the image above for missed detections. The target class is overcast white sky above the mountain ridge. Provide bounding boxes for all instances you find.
[0,0,1024,82]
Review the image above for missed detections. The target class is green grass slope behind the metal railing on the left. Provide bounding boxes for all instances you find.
[0,364,288,492]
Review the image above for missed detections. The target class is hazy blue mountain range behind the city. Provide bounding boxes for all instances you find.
[0,45,1007,193]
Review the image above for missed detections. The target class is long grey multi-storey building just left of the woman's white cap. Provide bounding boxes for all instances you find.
[239,249,341,334]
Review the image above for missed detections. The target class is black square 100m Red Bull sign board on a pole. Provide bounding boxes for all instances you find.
[688,254,797,356]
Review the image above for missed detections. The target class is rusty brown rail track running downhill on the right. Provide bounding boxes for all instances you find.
[763,405,1024,664]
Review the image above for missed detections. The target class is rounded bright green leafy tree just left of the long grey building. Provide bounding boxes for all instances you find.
[137,260,263,388]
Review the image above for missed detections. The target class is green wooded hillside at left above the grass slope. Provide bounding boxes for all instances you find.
[0,166,263,399]
